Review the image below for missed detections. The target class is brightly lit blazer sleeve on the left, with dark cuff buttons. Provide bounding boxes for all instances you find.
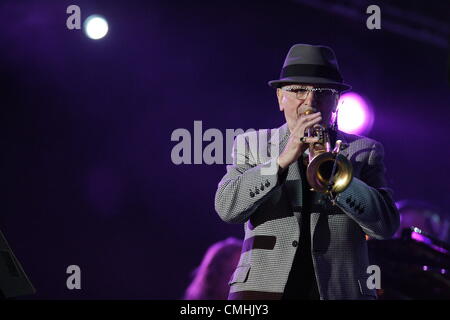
[214,132,288,223]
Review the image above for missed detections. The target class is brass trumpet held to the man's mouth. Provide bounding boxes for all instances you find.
[305,110,353,196]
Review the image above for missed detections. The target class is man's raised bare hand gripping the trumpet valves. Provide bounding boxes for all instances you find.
[278,112,322,169]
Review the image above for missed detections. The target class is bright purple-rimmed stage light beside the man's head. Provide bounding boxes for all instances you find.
[338,92,374,134]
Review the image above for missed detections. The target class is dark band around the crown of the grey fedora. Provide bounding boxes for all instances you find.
[280,64,342,82]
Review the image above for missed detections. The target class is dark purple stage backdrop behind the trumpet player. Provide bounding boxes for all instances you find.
[0,0,450,299]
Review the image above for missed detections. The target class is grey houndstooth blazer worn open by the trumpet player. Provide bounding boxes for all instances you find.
[215,123,399,300]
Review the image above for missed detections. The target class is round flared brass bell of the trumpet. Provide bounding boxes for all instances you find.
[306,152,353,193]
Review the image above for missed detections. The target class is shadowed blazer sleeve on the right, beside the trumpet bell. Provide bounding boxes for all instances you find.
[336,142,400,239]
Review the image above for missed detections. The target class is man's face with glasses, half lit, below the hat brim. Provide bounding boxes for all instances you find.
[277,84,339,131]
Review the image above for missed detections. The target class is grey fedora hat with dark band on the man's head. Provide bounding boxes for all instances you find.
[269,44,351,91]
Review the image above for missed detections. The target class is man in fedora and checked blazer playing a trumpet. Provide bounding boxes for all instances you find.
[215,44,399,300]
